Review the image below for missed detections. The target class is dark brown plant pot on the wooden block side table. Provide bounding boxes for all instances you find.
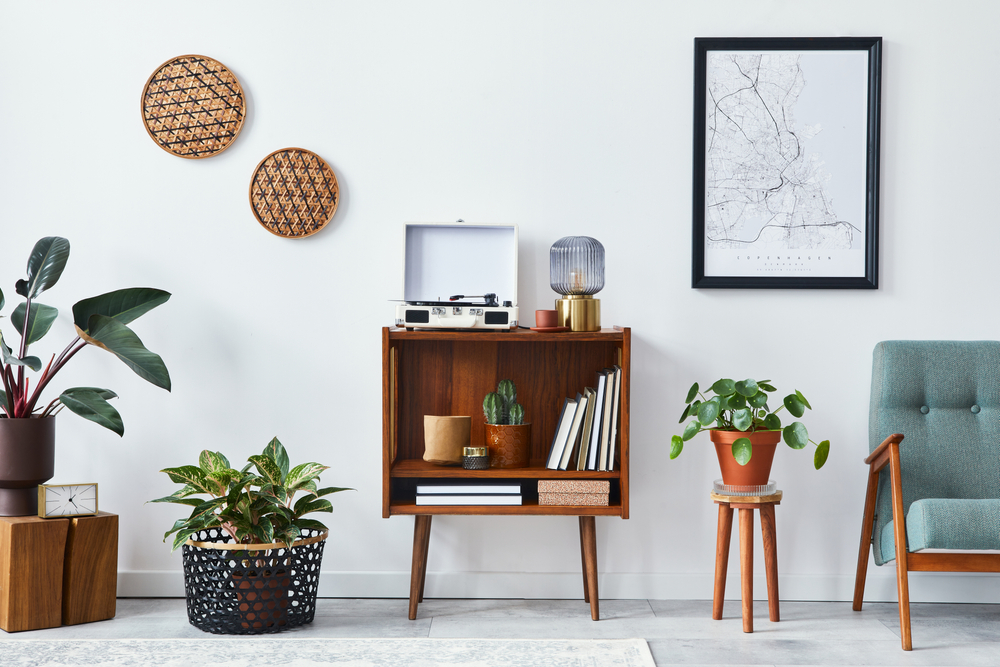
[0,417,56,516]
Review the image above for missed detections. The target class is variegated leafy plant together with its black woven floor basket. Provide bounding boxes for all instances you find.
[150,438,347,634]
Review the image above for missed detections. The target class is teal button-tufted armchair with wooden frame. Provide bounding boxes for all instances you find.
[854,341,1000,651]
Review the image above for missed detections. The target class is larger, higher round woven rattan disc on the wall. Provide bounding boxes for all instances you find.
[142,56,246,160]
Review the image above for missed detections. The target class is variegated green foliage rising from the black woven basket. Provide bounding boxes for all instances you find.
[149,438,353,550]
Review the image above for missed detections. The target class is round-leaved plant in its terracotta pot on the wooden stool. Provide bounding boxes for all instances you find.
[670,379,830,486]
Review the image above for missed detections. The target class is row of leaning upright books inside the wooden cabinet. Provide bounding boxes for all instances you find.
[545,366,622,470]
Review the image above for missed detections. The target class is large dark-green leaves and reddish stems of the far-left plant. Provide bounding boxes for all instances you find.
[0,236,170,436]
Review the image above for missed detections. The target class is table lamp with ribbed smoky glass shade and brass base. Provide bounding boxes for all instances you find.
[549,236,604,331]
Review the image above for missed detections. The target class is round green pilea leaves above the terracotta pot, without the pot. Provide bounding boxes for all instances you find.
[670,379,830,470]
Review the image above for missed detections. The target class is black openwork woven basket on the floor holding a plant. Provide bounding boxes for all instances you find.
[183,528,326,635]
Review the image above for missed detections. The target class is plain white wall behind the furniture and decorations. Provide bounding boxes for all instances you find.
[0,0,1000,600]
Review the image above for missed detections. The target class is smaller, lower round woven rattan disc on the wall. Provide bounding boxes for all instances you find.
[250,148,340,238]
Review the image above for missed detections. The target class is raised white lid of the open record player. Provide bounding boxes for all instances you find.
[403,222,517,306]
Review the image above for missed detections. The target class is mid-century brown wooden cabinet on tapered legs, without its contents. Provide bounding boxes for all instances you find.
[382,327,631,620]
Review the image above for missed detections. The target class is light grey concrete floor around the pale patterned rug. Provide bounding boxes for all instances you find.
[0,598,1000,667]
